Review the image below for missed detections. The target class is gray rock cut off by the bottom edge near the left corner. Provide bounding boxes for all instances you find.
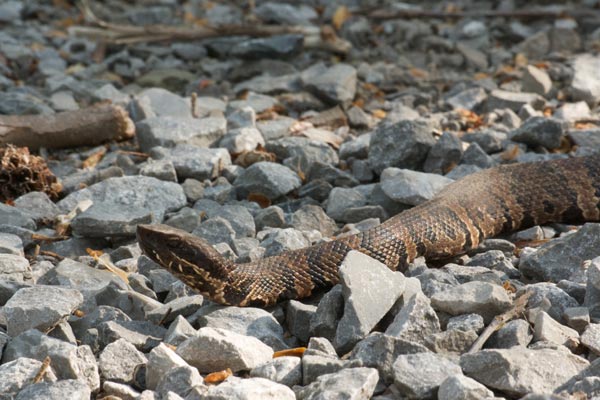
[15,379,93,400]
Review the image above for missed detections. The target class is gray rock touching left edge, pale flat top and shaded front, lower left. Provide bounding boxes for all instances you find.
[2,285,83,337]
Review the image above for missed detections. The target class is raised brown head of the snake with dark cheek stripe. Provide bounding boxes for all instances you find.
[137,225,234,299]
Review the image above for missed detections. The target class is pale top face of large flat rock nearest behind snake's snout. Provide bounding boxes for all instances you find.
[59,176,186,221]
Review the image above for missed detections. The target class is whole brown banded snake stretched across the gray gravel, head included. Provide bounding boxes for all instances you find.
[137,156,600,307]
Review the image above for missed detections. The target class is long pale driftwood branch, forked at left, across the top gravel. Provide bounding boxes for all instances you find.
[69,1,352,54]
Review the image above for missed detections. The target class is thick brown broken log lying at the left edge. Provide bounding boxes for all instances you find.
[0,104,135,150]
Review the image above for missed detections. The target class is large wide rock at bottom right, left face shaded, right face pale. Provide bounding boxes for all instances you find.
[460,347,589,397]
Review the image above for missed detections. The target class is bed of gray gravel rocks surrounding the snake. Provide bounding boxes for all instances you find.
[0,0,600,400]
